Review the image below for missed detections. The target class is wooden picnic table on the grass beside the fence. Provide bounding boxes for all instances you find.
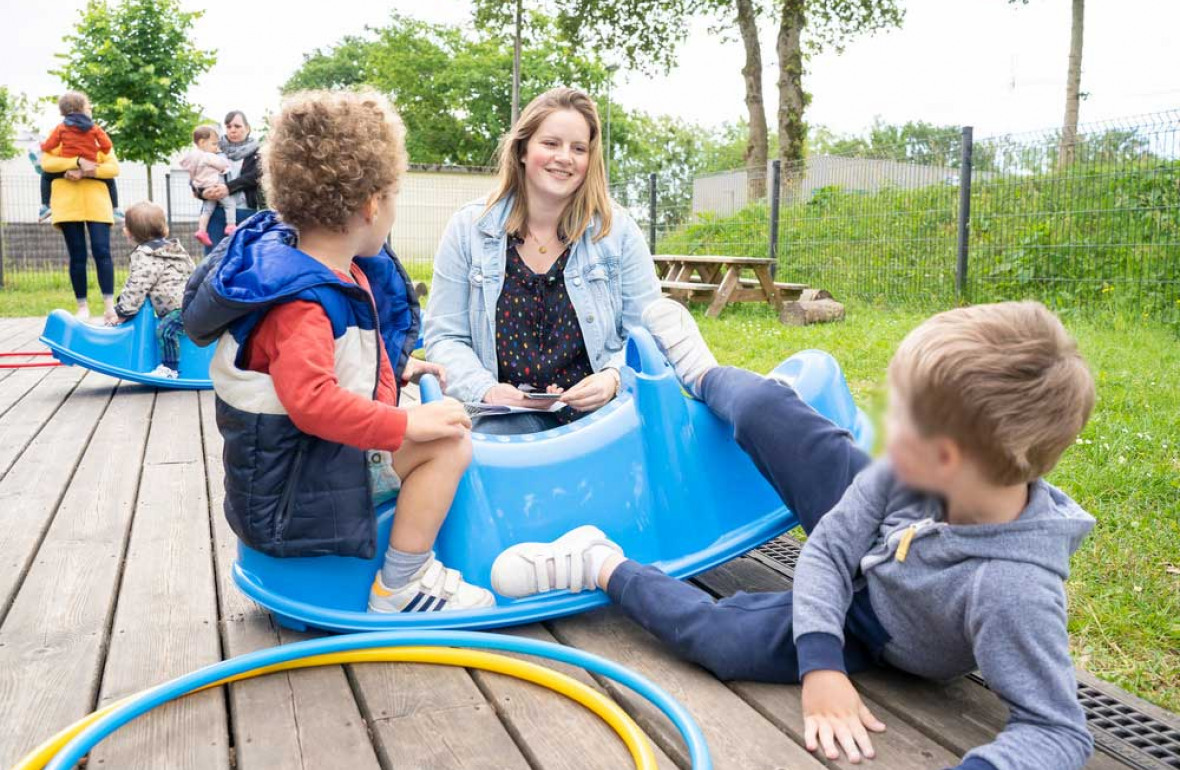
[653,254,807,318]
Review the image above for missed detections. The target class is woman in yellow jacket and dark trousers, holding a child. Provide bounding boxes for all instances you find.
[41,136,119,323]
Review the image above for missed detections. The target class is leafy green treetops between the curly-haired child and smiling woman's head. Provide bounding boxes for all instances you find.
[283,13,608,166]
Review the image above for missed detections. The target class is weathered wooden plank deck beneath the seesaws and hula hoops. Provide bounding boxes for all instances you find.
[0,320,1174,770]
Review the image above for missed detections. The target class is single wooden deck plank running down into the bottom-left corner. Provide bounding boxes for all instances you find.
[0,382,155,768]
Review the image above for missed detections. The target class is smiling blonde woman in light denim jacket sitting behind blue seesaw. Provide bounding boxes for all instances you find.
[426,88,660,434]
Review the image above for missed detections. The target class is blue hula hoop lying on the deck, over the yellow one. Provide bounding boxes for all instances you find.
[25,631,713,770]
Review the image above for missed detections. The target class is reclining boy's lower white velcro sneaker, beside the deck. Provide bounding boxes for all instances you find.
[492,525,623,599]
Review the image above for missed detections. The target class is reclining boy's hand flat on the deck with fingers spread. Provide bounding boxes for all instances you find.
[802,671,885,763]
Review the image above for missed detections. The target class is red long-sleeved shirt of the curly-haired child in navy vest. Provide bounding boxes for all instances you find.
[244,269,407,452]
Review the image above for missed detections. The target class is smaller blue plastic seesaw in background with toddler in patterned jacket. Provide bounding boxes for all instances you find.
[41,300,217,390]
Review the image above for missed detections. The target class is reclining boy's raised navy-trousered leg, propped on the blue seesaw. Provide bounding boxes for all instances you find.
[699,367,870,533]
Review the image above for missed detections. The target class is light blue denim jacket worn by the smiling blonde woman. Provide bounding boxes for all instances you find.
[425,197,660,401]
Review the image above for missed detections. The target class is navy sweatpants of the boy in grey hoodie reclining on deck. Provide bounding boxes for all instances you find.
[607,367,889,683]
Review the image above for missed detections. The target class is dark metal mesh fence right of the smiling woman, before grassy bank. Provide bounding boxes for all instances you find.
[637,111,1180,321]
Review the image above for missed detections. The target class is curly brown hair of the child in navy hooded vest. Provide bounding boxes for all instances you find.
[262,91,407,232]
